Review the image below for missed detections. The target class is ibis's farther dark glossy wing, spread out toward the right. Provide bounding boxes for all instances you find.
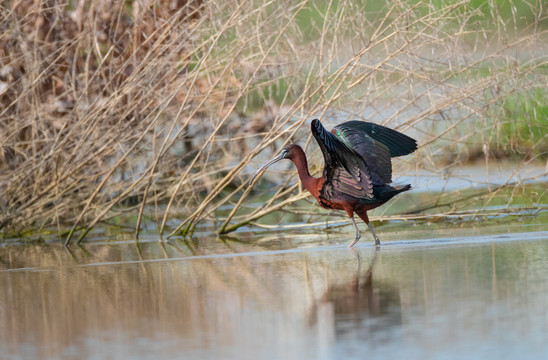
[331,120,417,185]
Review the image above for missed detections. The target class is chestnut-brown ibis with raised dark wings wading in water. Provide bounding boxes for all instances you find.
[250,119,417,248]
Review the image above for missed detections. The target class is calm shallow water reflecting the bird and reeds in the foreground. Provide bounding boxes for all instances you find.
[0,221,548,359]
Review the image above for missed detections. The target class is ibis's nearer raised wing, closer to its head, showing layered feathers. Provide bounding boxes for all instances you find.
[311,119,373,199]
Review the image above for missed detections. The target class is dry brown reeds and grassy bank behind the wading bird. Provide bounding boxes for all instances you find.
[0,0,548,245]
